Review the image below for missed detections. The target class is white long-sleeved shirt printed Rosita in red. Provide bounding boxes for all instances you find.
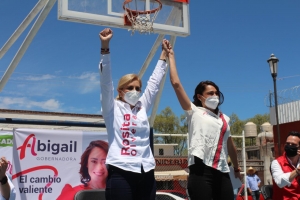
[99,54,167,173]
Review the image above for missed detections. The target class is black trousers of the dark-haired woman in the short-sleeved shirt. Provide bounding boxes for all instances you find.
[188,157,234,200]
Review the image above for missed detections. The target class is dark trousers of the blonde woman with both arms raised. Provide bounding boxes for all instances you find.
[105,165,156,200]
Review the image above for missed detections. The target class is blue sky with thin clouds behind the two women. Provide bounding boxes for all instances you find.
[0,0,300,120]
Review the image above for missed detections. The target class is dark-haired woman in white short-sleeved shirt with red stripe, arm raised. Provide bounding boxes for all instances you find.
[168,41,240,200]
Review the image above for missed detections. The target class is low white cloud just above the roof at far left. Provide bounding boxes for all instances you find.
[0,97,63,112]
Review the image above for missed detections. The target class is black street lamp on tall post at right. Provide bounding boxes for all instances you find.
[267,54,281,156]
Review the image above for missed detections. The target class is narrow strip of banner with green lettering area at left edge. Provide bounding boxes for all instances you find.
[0,131,13,175]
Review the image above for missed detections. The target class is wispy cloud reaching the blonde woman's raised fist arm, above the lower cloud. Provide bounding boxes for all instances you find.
[4,72,99,99]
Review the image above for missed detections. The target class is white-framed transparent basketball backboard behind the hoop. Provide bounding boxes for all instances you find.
[58,0,190,37]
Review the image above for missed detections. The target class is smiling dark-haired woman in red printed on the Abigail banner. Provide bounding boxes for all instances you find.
[57,140,108,200]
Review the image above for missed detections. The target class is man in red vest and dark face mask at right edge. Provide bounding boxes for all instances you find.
[271,131,300,200]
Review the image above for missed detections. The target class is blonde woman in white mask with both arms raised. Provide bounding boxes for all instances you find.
[99,28,167,200]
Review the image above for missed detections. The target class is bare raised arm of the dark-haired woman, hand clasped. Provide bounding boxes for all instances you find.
[163,40,192,110]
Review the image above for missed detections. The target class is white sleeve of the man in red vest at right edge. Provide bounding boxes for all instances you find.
[271,160,291,188]
